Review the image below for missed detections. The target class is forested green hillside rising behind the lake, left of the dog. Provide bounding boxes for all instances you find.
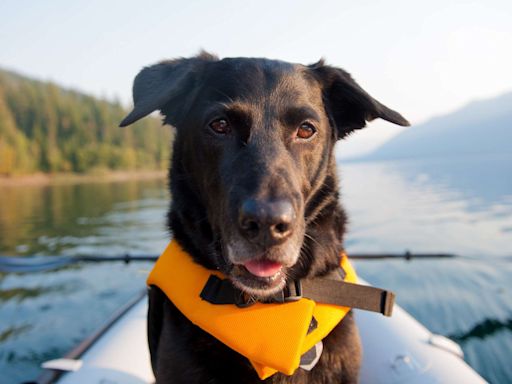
[0,70,172,175]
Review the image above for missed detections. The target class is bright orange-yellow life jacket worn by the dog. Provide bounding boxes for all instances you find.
[147,240,357,380]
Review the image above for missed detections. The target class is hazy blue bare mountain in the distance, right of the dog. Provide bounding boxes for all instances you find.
[360,92,512,160]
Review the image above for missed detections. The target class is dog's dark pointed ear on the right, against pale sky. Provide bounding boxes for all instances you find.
[309,60,410,139]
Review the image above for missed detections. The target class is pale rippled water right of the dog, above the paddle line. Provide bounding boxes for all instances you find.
[341,155,512,258]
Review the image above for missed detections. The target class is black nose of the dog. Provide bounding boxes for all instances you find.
[238,199,295,247]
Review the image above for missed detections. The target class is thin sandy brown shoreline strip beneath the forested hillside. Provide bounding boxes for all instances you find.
[0,170,167,188]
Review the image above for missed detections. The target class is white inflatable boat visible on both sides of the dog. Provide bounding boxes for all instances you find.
[37,284,486,384]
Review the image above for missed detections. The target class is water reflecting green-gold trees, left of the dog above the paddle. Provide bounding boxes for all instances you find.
[0,180,168,255]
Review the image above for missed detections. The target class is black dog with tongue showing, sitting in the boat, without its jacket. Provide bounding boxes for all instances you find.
[121,53,408,384]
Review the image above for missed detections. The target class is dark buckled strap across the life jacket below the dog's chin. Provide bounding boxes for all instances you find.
[200,275,395,316]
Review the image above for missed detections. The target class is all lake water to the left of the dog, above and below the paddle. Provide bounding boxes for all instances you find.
[0,180,168,383]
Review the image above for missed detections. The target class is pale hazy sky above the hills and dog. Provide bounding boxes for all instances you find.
[0,0,512,154]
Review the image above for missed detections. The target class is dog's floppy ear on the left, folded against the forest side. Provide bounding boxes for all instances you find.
[119,52,217,127]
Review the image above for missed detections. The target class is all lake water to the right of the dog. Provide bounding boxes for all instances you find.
[341,155,512,383]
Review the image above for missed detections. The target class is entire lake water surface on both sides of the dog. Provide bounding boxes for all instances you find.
[0,155,512,383]
